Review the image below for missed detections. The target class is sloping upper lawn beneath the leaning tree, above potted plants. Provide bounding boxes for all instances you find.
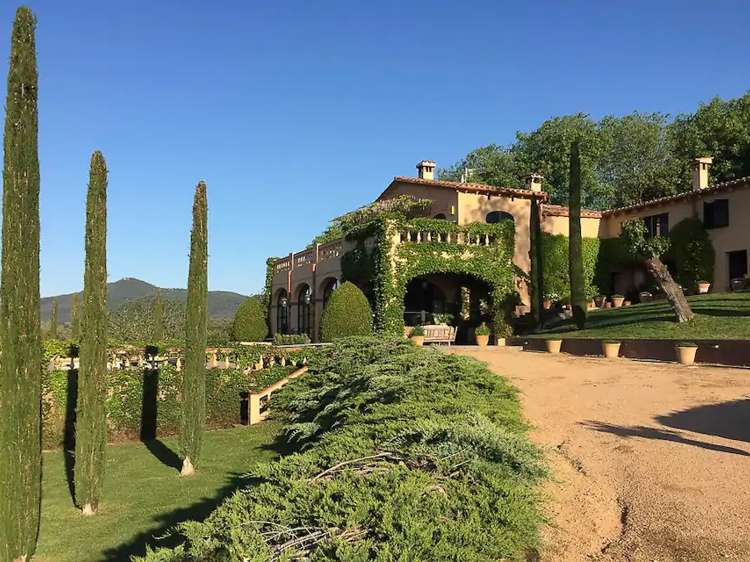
[541,292,750,340]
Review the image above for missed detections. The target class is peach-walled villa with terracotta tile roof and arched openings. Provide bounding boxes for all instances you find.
[270,158,750,338]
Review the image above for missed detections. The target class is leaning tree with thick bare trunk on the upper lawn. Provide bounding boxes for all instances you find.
[620,219,695,322]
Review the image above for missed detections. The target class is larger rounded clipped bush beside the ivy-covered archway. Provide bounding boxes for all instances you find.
[320,281,372,342]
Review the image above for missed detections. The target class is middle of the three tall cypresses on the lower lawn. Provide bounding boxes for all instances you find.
[75,151,107,515]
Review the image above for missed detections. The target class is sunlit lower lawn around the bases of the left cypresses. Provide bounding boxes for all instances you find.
[34,421,280,562]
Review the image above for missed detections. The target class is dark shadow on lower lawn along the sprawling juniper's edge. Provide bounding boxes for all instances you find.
[104,473,260,562]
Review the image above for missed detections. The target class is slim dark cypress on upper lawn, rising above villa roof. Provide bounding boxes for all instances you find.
[568,141,586,330]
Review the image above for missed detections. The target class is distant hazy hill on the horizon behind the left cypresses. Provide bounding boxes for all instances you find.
[41,277,247,322]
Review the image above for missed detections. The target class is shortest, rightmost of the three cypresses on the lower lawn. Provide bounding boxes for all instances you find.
[180,182,208,476]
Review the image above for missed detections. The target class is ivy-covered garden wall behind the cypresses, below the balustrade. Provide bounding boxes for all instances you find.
[42,364,297,449]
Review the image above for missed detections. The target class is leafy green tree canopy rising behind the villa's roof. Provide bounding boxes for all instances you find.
[438,92,750,209]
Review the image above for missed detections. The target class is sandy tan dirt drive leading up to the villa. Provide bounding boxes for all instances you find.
[455,348,750,562]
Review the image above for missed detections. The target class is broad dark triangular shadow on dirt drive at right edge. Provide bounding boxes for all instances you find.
[656,398,750,443]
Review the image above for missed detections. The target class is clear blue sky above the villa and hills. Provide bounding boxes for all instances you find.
[0,0,750,296]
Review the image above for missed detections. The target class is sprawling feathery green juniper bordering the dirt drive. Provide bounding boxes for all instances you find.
[141,337,546,562]
